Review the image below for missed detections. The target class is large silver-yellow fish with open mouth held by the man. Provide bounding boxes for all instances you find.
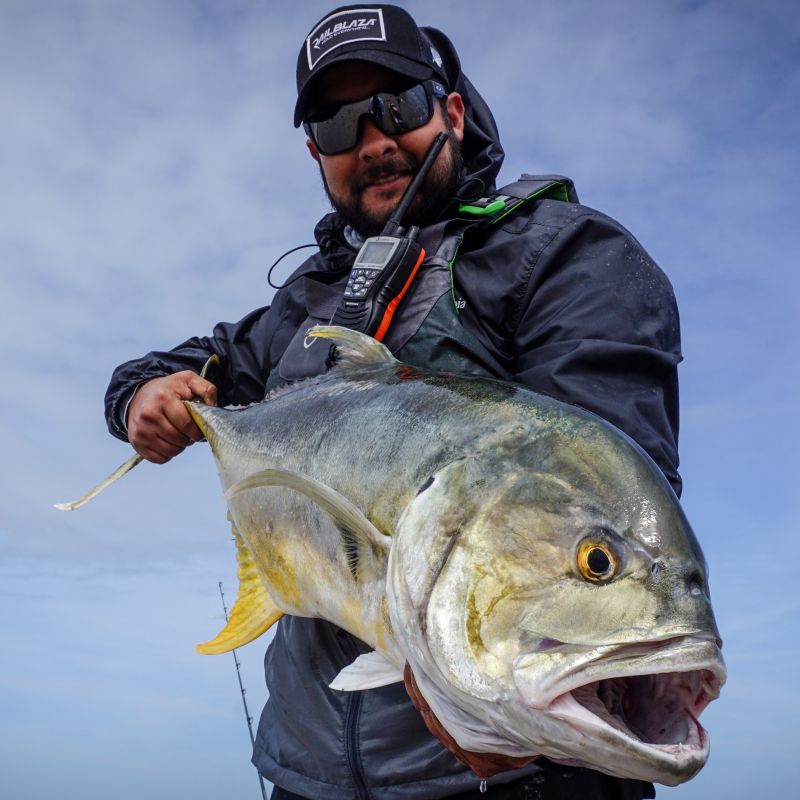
[188,328,725,785]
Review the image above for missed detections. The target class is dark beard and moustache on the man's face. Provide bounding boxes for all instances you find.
[320,130,464,238]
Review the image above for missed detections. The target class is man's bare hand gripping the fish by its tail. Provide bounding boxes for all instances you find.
[128,370,217,464]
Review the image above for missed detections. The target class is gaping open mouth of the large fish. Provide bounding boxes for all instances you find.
[560,670,720,755]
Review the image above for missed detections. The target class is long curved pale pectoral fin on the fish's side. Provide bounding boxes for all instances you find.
[225,469,391,578]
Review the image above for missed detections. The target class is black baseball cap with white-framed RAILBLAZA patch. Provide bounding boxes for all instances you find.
[294,5,447,128]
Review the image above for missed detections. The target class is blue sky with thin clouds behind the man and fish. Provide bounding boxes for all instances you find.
[0,0,800,800]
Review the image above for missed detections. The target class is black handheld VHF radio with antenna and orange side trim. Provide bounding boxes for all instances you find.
[331,133,447,342]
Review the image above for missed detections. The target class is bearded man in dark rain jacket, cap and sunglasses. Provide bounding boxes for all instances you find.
[106,5,680,800]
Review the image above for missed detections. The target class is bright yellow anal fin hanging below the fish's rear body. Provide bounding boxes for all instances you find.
[195,520,283,655]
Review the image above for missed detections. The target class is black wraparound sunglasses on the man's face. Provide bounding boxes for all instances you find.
[303,81,447,156]
